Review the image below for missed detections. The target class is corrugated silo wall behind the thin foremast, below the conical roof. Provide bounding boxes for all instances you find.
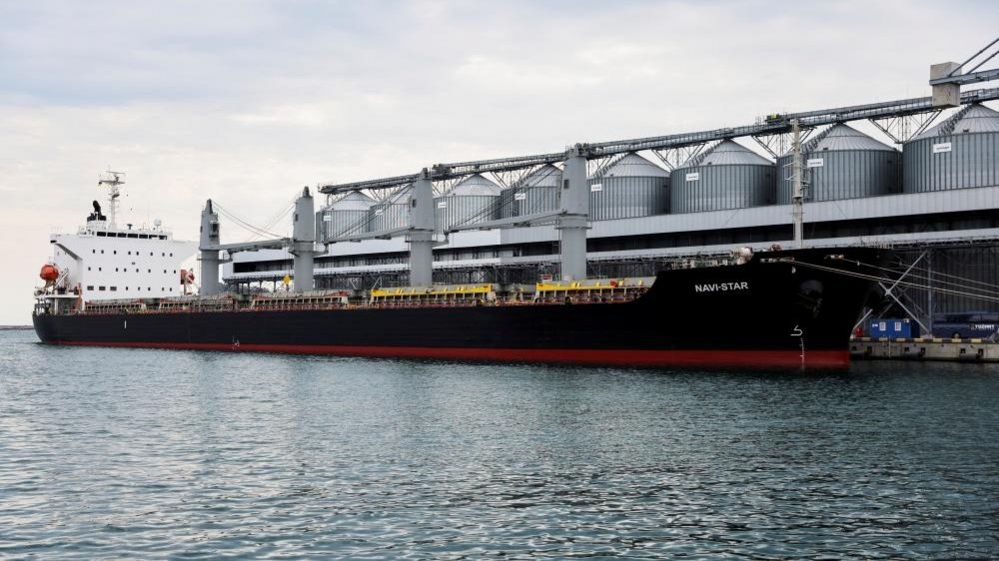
[777,150,902,205]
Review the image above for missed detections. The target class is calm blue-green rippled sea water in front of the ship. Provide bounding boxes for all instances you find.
[0,331,999,559]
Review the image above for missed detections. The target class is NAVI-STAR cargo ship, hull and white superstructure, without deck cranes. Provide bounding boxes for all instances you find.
[32,176,880,368]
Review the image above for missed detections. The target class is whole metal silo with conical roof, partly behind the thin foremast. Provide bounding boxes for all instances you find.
[777,123,902,205]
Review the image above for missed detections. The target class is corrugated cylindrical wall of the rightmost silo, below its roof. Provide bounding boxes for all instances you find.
[902,133,999,193]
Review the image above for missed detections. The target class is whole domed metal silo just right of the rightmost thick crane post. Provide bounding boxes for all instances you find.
[589,152,669,220]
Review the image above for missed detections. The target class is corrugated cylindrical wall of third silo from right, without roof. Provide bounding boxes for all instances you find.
[669,165,777,214]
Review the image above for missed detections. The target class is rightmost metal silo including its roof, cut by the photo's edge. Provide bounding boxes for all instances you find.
[902,104,999,193]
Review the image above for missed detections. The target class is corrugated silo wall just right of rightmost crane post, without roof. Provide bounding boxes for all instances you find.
[588,177,669,220]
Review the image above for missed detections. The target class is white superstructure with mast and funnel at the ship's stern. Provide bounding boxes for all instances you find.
[39,172,196,302]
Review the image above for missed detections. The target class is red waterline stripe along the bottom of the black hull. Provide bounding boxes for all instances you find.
[53,341,850,368]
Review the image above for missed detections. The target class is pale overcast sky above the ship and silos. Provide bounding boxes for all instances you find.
[0,0,999,324]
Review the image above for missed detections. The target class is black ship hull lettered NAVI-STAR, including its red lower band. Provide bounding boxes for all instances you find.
[33,248,877,368]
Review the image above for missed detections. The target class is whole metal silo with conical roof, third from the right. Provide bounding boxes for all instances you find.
[670,140,777,214]
